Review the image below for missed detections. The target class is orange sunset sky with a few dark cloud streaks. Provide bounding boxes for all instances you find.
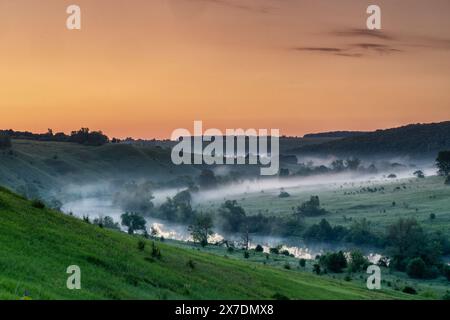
[0,0,450,139]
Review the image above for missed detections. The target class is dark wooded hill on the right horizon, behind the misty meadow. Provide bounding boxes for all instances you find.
[289,121,450,158]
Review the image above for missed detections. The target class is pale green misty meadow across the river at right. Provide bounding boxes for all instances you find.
[196,176,450,236]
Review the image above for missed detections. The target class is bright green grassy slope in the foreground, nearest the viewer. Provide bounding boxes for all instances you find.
[0,188,411,299]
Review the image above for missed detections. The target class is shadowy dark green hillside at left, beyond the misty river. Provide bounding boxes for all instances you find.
[0,140,197,198]
